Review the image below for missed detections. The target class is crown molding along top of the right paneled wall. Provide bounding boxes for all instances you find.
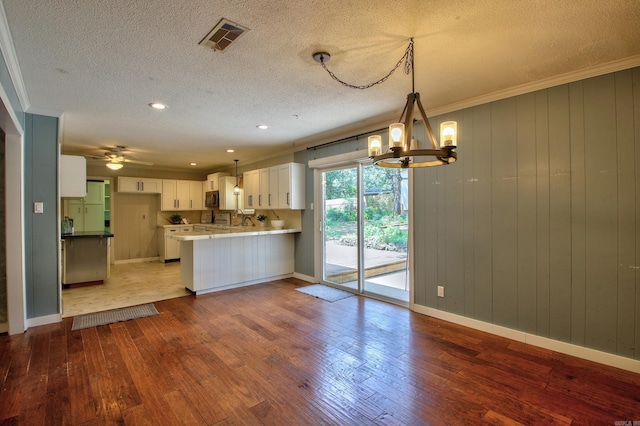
[426,55,640,117]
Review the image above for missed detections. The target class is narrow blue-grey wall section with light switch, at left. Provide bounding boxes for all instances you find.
[24,114,60,318]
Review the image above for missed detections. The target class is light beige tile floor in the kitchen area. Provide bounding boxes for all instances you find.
[62,262,191,317]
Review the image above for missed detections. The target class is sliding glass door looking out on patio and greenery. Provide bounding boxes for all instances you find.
[321,164,409,303]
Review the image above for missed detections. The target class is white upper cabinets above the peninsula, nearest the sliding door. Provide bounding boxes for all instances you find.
[244,163,305,210]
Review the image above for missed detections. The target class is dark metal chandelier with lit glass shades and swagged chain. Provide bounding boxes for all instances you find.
[313,38,458,168]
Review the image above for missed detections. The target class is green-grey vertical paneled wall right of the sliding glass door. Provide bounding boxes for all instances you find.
[414,68,640,359]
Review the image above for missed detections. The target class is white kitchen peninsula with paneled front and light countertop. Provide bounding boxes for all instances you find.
[166,225,301,294]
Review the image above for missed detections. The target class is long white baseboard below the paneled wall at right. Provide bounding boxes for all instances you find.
[413,305,640,373]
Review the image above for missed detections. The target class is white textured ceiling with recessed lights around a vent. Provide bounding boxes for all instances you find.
[2,0,640,171]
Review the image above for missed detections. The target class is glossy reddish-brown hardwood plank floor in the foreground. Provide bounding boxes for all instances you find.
[0,279,640,425]
